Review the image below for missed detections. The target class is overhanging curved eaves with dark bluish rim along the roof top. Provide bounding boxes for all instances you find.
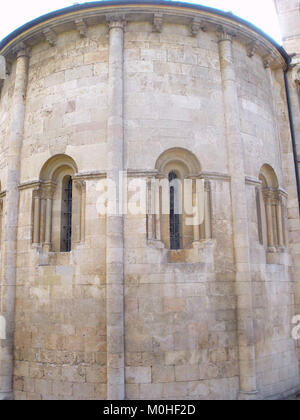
[0,0,291,67]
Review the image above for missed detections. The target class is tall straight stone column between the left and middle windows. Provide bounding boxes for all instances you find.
[106,16,125,400]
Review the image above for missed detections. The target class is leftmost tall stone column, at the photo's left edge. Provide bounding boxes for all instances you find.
[0,45,29,400]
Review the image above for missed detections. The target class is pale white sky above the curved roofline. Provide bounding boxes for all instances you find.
[0,0,281,44]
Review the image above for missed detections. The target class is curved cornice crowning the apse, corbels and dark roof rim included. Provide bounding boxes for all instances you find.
[0,1,288,67]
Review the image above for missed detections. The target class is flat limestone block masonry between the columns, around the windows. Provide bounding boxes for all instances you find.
[0,6,300,399]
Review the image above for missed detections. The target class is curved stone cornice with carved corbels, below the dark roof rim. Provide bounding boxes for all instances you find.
[0,5,286,68]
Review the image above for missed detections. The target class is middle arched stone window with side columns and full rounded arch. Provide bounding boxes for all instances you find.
[147,148,212,250]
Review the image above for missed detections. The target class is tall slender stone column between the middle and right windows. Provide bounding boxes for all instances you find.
[219,31,258,399]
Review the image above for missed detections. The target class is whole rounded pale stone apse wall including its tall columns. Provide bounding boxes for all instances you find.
[0,3,300,399]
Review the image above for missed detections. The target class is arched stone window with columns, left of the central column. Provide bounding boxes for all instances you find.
[32,155,85,252]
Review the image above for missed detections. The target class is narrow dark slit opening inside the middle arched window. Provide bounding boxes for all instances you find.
[169,171,180,249]
